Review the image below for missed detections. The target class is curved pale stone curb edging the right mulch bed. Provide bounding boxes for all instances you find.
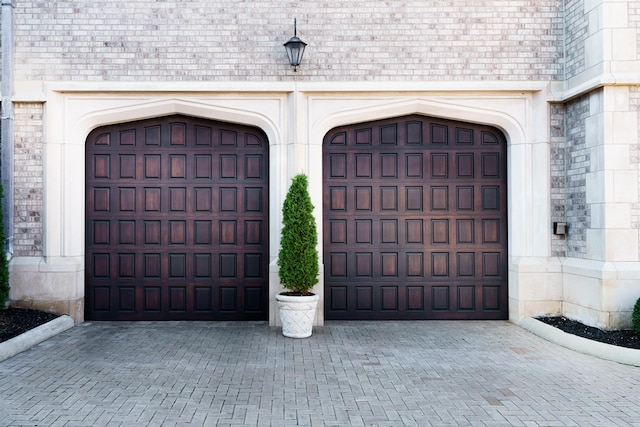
[519,317,640,366]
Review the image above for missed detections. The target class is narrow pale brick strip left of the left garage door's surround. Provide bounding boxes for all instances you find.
[14,104,43,256]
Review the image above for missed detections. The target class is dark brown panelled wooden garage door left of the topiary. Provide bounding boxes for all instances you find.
[85,116,269,320]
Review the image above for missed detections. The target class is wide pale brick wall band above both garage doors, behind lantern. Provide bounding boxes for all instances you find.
[15,0,564,81]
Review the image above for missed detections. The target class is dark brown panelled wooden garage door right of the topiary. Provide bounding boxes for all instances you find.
[323,115,508,319]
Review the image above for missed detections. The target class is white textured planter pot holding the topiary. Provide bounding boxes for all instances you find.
[276,294,318,338]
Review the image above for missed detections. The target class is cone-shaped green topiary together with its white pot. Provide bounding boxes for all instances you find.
[276,174,319,338]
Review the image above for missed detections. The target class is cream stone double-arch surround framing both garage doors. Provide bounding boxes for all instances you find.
[12,84,562,325]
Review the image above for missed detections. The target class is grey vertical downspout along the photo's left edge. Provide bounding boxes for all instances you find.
[0,0,14,258]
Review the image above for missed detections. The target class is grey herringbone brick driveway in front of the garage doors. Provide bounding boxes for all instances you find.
[0,321,640,426]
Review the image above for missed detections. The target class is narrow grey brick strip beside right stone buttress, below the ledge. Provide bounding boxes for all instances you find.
[564,94,591,258]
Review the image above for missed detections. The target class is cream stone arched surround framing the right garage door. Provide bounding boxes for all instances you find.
[301,93,562,321]
